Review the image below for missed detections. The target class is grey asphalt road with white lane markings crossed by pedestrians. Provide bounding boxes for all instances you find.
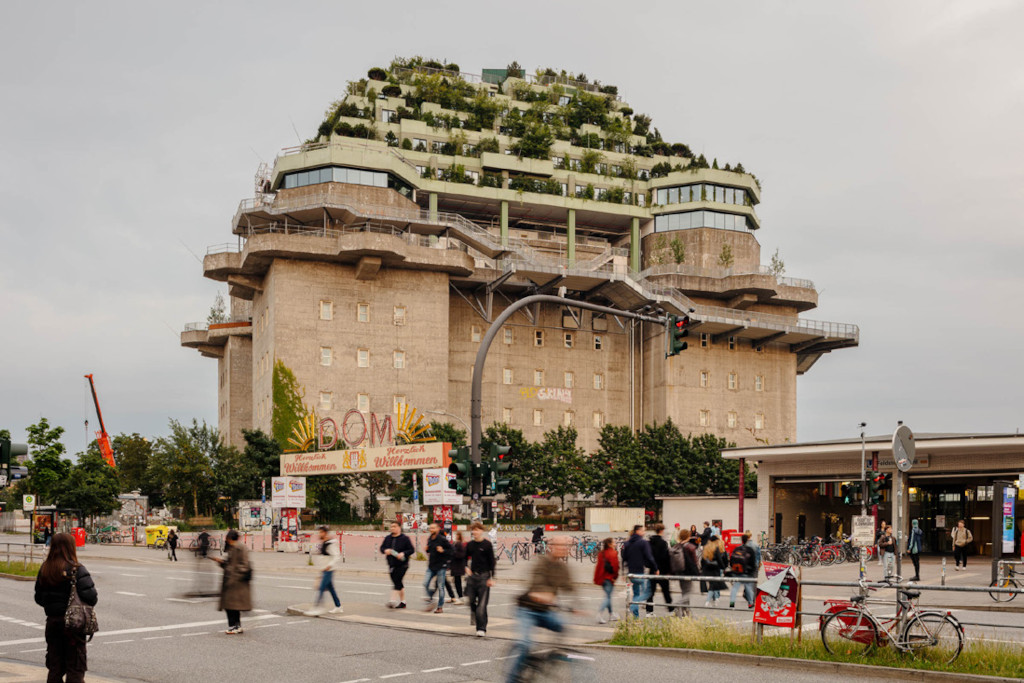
[0,558,913,683]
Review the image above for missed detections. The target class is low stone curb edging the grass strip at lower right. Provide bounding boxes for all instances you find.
[589,644,1020,683]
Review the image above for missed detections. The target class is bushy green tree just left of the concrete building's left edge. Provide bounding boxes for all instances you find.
[151,420,222,517]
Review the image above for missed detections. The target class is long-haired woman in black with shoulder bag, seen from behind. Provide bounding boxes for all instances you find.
[36,533,97,683]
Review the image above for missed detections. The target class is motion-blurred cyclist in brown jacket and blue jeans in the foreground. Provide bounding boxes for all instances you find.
[508,537,572,683]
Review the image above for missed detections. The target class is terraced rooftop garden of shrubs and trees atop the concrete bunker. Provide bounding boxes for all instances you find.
[307,56,760,194]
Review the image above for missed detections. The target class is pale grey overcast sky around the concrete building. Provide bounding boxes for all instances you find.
[0,0,1024,453]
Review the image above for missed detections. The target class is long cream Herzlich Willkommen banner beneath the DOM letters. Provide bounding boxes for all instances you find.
[281,441,444,475]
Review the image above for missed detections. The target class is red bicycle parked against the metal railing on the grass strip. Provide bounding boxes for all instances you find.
[819,577,964,664]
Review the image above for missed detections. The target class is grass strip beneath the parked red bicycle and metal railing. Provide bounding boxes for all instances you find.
[610,616,1024,678]
